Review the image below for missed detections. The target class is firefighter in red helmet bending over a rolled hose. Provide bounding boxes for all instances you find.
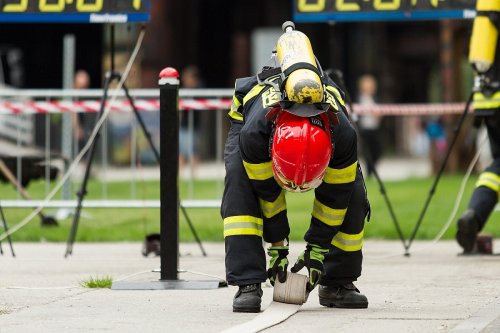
[221,22,369,312]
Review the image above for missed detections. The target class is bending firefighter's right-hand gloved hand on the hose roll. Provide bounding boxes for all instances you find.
[291,244,329,292]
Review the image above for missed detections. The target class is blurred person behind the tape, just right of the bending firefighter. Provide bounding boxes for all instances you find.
[358,74,382,176]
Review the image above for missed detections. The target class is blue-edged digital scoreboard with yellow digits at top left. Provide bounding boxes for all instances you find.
[0,0,150,23]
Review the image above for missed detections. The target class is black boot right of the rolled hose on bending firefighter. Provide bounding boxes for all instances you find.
[318,283,368,309]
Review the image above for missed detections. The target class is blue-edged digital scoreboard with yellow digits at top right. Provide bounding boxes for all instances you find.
[293,0,476,22]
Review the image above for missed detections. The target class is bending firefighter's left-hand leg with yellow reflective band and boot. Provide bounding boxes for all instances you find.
[221,124,267,312]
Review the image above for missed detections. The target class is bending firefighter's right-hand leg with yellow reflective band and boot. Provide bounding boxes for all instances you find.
[318,169,369,308]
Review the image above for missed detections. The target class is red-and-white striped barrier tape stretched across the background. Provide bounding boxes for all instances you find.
[0,98,465,116]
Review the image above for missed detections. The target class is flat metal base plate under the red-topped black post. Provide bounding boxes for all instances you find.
[111,280,227,290]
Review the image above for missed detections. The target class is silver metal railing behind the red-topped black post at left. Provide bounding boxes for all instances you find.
[0,89,233,208]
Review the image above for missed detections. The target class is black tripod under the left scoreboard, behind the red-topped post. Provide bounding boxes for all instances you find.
[65,24,206,257]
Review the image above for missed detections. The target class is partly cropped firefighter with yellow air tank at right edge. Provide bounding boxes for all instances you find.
[456,0,500,254]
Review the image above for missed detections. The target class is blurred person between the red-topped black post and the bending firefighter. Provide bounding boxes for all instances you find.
[179,65,203,171]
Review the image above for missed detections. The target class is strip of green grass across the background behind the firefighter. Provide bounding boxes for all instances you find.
[0,175,500,242]
